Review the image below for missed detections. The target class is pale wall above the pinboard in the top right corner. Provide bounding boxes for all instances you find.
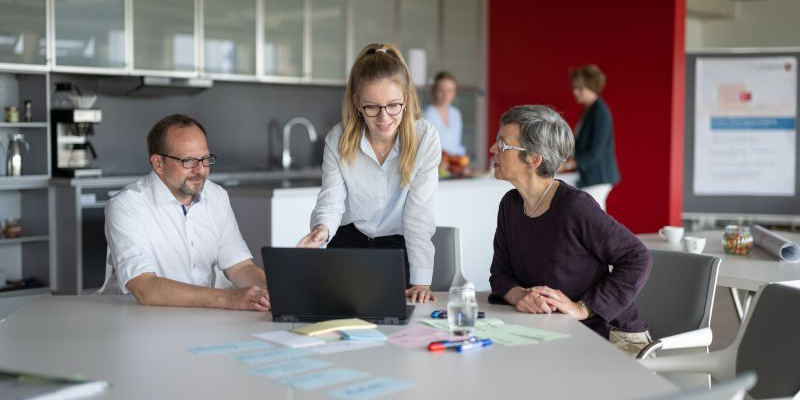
[686,0,800,50]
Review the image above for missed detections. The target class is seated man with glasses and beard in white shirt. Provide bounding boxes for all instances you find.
[101,114,270,311]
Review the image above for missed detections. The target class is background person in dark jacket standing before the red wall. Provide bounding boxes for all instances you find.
[564,64,620,211]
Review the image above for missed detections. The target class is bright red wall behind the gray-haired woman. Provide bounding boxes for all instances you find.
[488,0,685,233]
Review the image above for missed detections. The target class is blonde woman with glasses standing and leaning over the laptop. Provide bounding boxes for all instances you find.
[297,44,442,303]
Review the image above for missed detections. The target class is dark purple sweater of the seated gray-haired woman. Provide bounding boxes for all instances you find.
[489,182,651,338]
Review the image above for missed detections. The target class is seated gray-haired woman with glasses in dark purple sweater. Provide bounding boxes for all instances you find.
[489,105,651,356]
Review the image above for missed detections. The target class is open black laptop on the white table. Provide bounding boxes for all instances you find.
[261,247,414,325]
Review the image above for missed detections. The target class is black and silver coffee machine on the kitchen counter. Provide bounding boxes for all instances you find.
[50,83,103,178]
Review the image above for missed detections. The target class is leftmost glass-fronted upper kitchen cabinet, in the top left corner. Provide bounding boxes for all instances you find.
[0,0,47,66]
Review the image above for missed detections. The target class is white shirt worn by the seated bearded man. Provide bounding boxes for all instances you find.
[103,172,252,293]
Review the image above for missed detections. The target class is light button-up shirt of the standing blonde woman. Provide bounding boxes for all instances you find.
[311,119,442,285]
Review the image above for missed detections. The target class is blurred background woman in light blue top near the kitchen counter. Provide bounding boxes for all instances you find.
[423,71,466,155]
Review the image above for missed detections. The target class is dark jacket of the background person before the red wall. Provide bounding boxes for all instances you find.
[575,98,620,187]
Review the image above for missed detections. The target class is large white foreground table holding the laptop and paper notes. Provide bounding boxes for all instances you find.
[0,293,678,400]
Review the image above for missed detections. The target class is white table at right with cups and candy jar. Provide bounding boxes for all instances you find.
[636,230,800,318]
